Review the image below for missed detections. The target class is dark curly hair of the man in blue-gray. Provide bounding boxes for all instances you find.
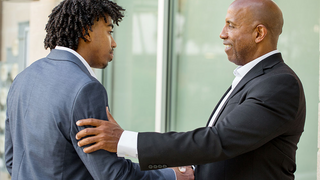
[44,0,125,50]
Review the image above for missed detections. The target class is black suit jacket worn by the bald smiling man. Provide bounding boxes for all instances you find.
[138,53,306,180]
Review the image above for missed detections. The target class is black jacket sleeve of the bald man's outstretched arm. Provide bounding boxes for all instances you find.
[138,74,305,170]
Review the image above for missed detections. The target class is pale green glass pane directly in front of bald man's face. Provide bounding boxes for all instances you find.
[169,0,236,131]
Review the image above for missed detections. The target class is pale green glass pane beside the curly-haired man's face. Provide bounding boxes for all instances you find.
[104,0,158,131]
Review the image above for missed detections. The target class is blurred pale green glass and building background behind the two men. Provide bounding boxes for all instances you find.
[0,0,320,180]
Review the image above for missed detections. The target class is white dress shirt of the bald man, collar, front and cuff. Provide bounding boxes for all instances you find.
[117,50,279,158]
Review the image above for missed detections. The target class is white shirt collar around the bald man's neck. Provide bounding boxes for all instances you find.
[233,50,279,78]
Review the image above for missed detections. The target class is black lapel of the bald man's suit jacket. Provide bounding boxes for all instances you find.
[207,53,283,126]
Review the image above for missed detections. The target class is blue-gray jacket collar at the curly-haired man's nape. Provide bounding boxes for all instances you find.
[47,49,91,76]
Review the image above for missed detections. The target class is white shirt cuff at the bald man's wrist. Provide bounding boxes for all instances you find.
[117,131,138,158]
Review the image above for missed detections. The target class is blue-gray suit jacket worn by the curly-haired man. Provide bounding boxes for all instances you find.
[5,50,175,180]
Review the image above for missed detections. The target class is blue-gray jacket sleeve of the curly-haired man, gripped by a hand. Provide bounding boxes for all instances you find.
[70,81,175,180]
